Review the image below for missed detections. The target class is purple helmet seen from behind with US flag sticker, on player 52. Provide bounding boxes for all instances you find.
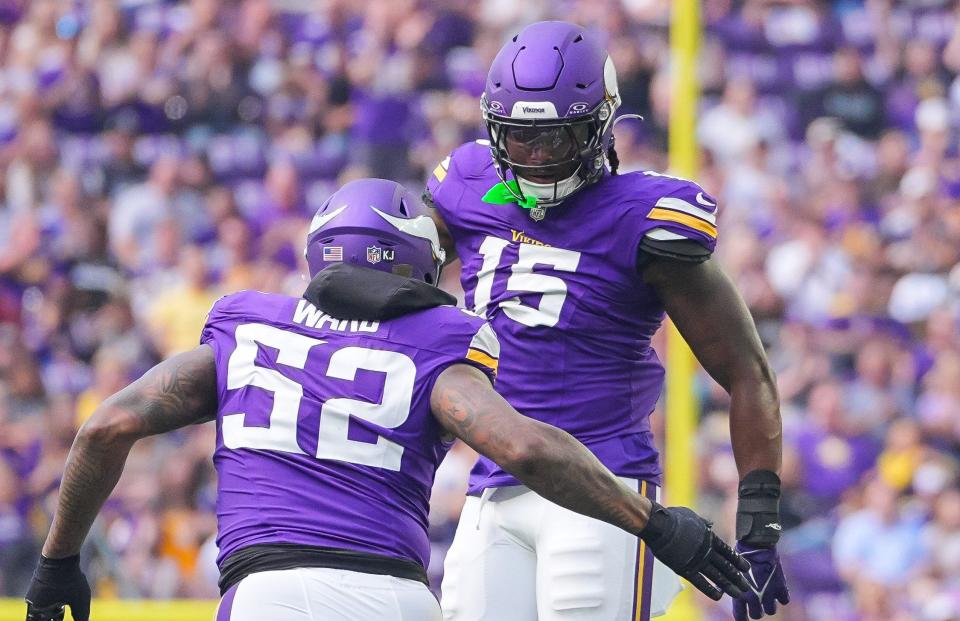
[305,179,446,285]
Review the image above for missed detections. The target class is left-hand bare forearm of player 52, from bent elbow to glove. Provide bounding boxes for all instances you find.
[43,414,133,558]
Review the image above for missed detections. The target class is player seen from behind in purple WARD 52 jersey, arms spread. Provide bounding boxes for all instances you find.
[20,179,747,621]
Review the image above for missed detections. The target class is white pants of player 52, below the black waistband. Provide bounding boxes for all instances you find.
[215,567,440,621]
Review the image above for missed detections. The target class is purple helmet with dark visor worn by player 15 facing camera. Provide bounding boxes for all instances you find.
[480,22,620,207]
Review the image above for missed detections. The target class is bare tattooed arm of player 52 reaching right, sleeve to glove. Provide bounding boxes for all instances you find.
[431,365,651,533]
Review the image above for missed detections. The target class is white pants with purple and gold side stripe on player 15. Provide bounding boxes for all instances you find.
[441,478,682,621]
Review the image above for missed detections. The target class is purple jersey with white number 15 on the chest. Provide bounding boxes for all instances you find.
[427,141,717,493]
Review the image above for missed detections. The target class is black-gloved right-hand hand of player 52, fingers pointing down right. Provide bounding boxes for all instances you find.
[640,503,750,600]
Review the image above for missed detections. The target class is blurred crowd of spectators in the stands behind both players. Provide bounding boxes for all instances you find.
[0,0,960,621]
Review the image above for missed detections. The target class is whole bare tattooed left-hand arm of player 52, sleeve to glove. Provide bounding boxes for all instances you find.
[43,345,217,558]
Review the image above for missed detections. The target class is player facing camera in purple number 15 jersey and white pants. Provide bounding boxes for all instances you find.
[424,22,788,621]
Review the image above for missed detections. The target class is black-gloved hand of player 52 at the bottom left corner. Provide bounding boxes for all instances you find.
[24,555,90,621]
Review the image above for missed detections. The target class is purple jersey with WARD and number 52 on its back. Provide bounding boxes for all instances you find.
[201,291,499,567]
